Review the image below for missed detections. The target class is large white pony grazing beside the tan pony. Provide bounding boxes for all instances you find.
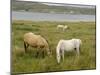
[56,39,82,63]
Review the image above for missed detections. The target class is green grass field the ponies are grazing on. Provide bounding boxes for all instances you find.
[11,21,96,73]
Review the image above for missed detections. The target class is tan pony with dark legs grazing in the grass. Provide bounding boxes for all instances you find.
[24,32,50,55]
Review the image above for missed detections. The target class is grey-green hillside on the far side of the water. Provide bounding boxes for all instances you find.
[12,0,95,15]
